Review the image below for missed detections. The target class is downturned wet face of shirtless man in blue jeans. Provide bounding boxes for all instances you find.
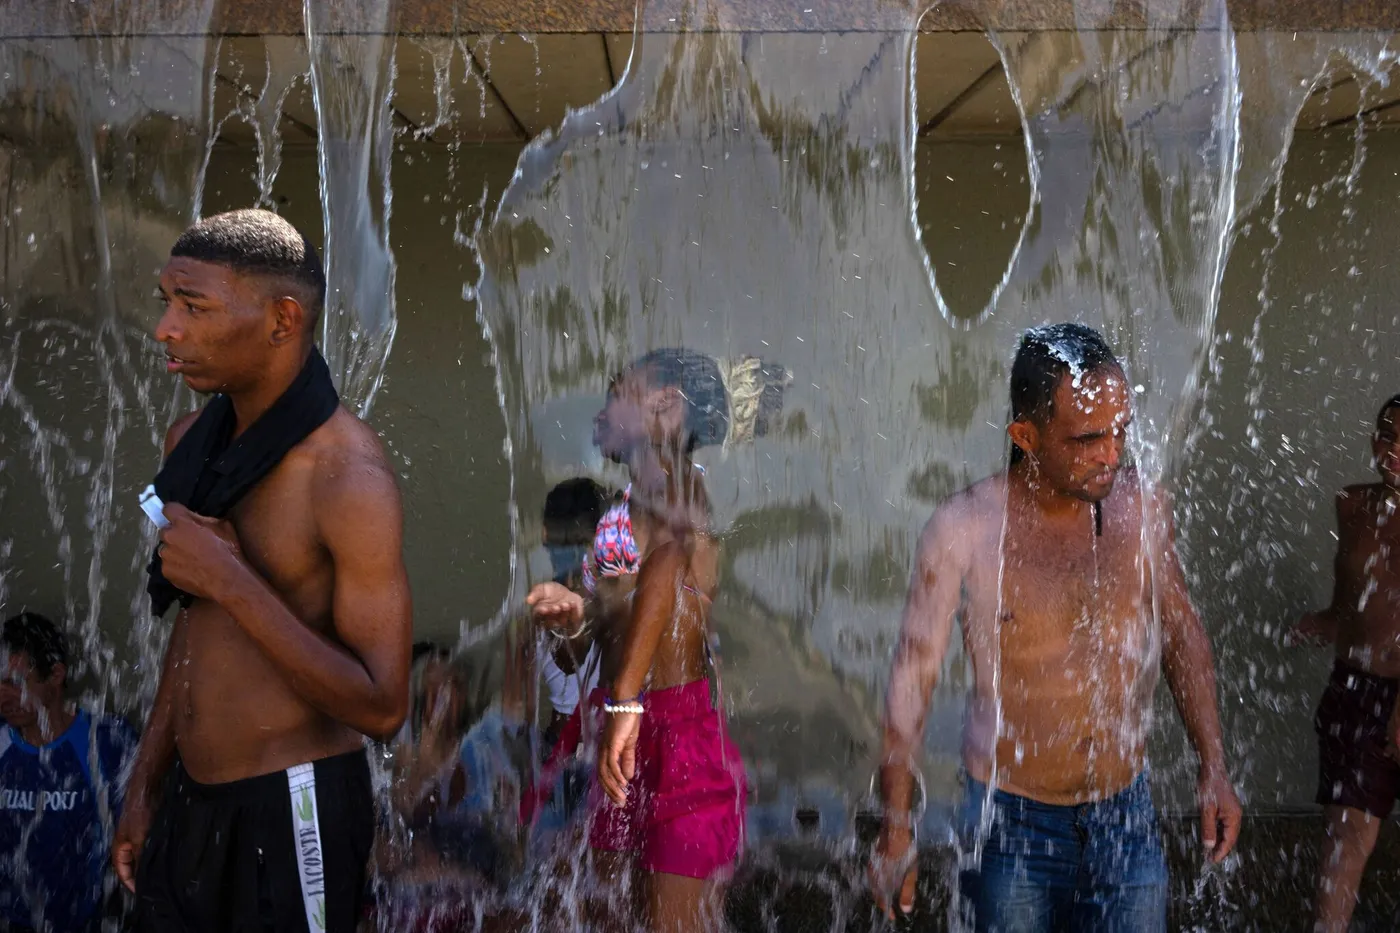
[1030,367,1133,502]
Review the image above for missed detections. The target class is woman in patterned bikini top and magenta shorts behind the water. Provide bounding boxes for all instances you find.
[526,349,788,933]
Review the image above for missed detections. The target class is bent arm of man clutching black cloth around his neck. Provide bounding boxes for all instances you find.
[161,439,412,738]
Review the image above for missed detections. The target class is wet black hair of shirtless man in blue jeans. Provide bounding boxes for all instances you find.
[1011,322,1123,464]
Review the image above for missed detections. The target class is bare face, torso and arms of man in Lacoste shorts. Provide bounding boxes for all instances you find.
[113,258,412,888]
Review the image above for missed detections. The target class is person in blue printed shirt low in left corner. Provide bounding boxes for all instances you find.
[0,612,136,933]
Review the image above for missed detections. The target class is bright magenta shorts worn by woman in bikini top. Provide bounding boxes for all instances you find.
[588,681,748,878]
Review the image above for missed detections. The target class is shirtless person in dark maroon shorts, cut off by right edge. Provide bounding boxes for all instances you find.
[1289,395,1400,933]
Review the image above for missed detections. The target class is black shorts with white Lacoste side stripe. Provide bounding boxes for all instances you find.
[136,751,374,933]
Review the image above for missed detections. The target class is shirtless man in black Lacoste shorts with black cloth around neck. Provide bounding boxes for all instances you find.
[112,210,412,933]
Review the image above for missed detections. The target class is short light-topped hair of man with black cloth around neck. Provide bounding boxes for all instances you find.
[171,207,326,329]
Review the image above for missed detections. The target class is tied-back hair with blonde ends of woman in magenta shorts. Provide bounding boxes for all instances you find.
[633,347,791,452]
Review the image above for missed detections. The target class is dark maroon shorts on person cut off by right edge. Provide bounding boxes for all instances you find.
[1313,661,1400,820]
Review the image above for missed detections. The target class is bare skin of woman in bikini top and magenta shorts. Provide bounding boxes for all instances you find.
[526,368,724,933]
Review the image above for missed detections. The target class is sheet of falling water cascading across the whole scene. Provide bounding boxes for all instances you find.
[0,0,1400,930]
